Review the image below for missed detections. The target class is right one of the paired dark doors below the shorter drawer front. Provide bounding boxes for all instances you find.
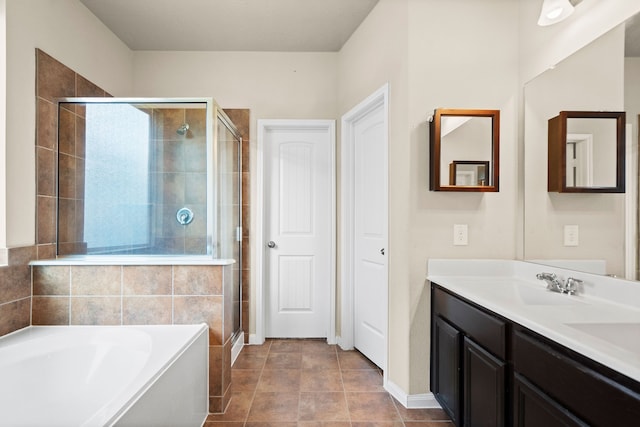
[463,337,506,427]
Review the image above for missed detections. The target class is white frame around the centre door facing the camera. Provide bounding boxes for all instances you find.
[249,119,336,344]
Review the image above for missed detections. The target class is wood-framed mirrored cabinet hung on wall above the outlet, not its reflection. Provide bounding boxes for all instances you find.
[429,108,500,192]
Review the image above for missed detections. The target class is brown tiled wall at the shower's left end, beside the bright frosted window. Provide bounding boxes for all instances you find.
[36,49,110,259]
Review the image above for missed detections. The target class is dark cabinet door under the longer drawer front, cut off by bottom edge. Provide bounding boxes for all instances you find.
[513,374,588,427]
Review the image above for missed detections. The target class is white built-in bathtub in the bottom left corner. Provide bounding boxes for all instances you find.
[0,324,209,427]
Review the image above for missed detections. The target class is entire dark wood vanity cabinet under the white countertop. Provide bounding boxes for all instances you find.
[431,283,640,427]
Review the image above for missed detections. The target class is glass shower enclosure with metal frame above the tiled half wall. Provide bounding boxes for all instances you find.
[57,98,242,338]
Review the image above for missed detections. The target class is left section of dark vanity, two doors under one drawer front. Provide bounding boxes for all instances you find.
[431,288,507,427]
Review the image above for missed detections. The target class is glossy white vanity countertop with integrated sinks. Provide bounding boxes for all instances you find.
[427,260,640,381]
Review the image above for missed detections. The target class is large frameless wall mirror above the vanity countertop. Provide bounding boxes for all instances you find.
[524,13,640,280]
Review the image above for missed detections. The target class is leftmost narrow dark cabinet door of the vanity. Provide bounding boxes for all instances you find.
[431,317,462,425]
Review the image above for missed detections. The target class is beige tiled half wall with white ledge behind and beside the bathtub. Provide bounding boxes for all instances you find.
[32,256,234,413]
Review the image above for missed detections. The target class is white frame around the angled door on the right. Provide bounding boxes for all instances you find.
[338,83,389,372]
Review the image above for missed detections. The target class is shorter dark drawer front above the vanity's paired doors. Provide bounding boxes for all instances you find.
[432,283,507,360]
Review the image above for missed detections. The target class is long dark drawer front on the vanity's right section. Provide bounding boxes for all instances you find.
[512,326,640,426]
